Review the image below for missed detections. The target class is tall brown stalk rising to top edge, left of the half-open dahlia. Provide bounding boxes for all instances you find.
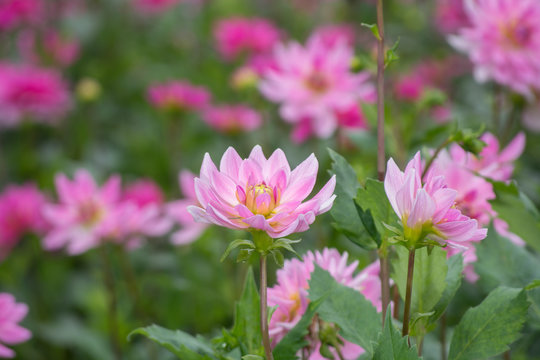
[377,0,390,326]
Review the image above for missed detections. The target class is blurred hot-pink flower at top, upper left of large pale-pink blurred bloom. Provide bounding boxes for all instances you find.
[214,17,280,60]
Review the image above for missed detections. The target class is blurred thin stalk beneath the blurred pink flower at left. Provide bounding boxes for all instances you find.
[99,244,122,360]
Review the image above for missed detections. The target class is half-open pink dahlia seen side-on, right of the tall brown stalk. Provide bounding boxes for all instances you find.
[384,153,487,246]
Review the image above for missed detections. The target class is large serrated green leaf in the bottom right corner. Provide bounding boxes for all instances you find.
[448,287,529,360]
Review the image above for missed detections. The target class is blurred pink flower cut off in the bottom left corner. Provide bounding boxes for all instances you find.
[0,293,32,358]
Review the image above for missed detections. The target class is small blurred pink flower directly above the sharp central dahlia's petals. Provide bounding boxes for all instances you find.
[202,105,262,134]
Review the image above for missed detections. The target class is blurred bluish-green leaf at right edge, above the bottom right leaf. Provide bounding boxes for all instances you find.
[474,227,540,291]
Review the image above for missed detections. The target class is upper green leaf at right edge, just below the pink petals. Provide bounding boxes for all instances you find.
[490,181,540,252]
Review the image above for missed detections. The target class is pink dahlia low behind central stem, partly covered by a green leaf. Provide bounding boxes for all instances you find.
[268,248,382,360]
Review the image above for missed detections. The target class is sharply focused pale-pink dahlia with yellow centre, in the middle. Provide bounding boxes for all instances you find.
[188,145,336,238]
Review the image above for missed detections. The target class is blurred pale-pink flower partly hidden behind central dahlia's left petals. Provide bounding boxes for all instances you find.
[167,170,208,245]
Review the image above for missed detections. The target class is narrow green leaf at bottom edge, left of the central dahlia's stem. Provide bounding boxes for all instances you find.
[128,325,215,360]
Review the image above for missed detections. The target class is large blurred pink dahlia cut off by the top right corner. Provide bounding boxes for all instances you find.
[450,0,540,96]
